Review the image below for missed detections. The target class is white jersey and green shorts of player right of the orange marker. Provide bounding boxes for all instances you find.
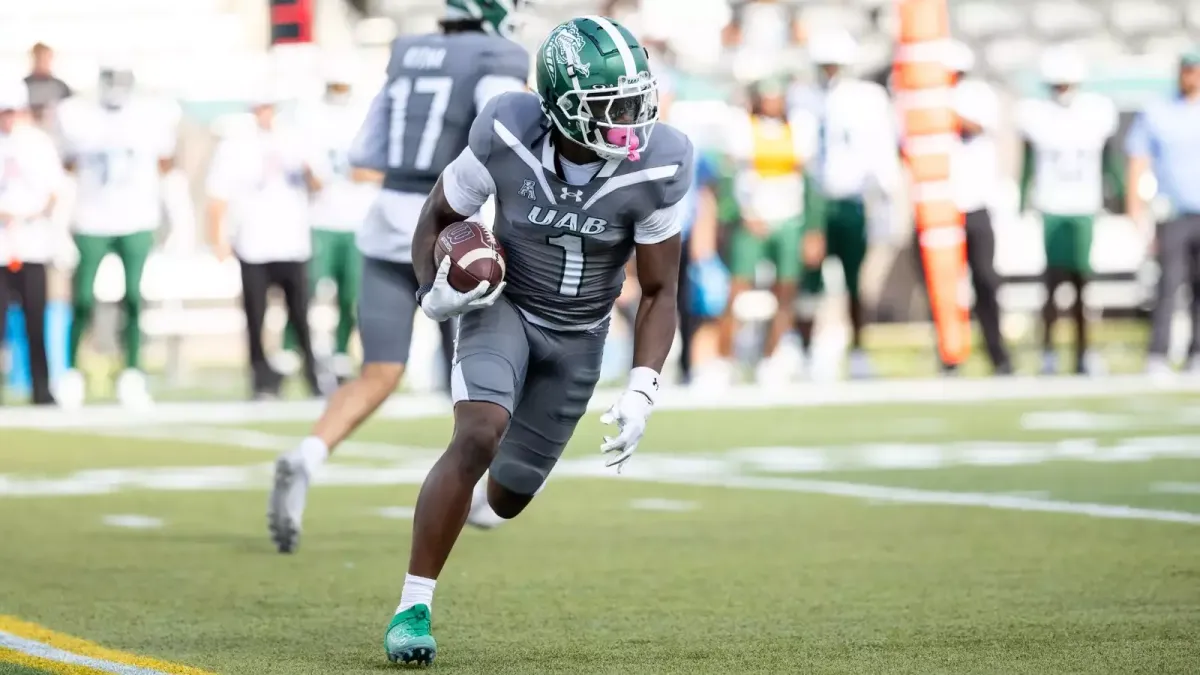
[1018,92,1124,274]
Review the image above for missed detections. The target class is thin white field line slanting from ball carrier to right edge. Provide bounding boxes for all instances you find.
[632,476,1200,525]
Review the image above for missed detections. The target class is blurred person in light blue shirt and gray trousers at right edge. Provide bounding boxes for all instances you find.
[1126,48,1200,374]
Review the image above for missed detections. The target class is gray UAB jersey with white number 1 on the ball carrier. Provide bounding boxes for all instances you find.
[470,92,692,329]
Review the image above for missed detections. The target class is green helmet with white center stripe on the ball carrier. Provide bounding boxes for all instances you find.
[534,17,659,161]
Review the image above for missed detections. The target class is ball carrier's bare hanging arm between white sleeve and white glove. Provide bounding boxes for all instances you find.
[634,234,683,372]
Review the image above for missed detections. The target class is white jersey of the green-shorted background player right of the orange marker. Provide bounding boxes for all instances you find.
[1018,92,1117,215]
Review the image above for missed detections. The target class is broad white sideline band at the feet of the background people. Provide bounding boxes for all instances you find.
[7,376,1200,430]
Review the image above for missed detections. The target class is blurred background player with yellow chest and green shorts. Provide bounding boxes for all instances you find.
[720,79,821,384]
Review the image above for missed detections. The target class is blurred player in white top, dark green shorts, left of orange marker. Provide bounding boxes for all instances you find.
[793,30,901,378]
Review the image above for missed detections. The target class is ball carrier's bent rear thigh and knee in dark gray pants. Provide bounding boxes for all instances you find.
[487,319,605,520]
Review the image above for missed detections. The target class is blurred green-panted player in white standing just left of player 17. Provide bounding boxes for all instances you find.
[283,60,382,381]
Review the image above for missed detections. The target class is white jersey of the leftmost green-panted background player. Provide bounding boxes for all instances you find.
[58,98,181,237]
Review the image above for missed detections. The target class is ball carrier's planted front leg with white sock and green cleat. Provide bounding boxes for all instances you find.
[384,297,530,663]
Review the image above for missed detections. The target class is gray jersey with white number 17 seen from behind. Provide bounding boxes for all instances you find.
[384,32,529,195]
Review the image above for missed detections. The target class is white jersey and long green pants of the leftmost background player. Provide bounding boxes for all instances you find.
[58,98,181,369]
